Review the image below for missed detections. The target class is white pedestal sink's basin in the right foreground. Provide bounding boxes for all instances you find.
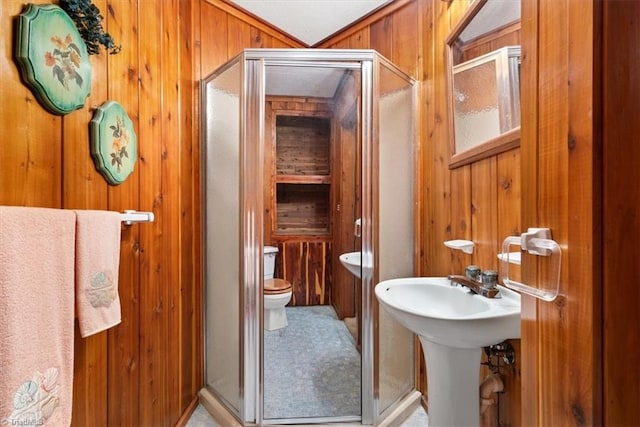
[376,277,520,348]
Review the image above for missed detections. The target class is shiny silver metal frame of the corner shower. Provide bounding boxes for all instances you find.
[202,49,417,425]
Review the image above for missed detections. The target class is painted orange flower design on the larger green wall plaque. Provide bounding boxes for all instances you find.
[44,34,84,90]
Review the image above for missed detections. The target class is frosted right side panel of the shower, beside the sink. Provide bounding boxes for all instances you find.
[373,58,417,420]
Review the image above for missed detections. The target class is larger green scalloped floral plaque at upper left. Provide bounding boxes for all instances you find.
[15,4,91,115]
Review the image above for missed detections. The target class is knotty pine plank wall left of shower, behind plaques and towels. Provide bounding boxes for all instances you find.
[0,0,300,426]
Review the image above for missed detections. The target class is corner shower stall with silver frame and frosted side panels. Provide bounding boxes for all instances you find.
[200,49,420,425]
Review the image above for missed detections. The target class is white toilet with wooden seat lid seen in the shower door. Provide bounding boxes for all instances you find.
[264,246,292,331]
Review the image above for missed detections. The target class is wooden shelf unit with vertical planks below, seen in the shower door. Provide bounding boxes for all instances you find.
[265,97,334,306]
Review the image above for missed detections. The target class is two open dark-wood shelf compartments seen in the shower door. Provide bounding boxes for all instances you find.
[274,115,331,235]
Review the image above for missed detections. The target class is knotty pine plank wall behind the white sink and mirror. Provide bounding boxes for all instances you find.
[320,0,521,425]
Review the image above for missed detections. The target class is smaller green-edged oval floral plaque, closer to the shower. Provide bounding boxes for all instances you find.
[89,101,138,185]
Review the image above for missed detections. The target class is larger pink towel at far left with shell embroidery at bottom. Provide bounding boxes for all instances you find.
[0,206,75,426]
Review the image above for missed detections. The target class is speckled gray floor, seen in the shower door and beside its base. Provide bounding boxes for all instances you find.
[192,306,427,427]
